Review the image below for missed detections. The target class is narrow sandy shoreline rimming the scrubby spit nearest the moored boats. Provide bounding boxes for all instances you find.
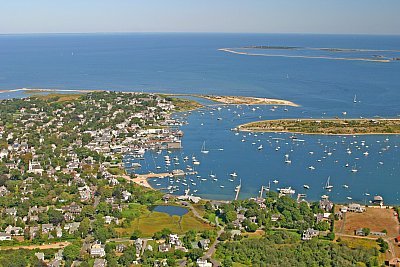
[237,118,400,136]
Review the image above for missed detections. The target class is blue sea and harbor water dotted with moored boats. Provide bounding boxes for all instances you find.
[0,34,400,204]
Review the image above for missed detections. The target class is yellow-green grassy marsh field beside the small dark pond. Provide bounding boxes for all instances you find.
[116,210,212,237]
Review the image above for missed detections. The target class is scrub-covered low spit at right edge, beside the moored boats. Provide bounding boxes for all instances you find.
[238,119,400,135]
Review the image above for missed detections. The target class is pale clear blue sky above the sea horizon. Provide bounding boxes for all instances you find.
[0,0,400,34]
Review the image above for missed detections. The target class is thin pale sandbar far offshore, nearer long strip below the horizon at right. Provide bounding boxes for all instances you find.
[218,48,392,63]
